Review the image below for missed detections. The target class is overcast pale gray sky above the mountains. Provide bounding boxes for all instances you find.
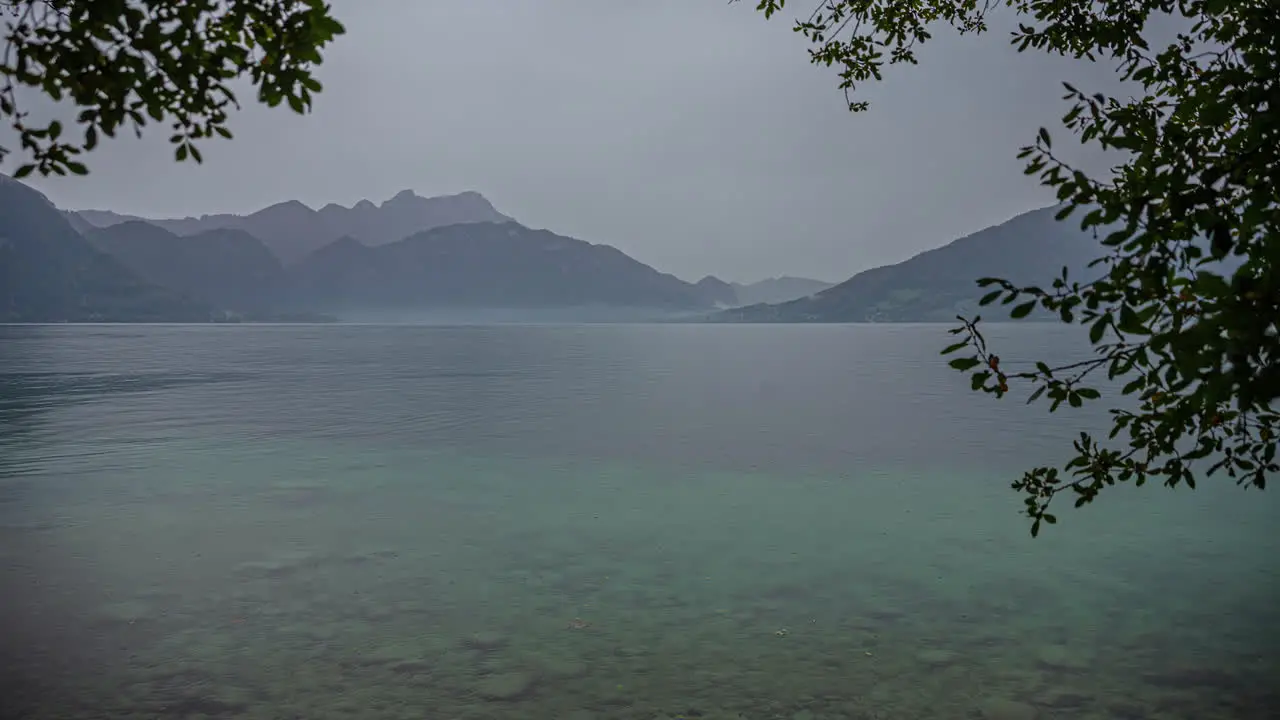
[15,0,1126,281]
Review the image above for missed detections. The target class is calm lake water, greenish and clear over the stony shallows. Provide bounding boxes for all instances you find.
[0,325,1280,720]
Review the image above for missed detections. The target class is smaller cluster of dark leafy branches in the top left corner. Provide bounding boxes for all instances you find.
[0,0,343,177]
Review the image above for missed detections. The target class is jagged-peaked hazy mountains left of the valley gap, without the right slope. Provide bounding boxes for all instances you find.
[0,177,839,322]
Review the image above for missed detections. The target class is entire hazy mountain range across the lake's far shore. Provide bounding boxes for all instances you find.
[0,176,1121,323]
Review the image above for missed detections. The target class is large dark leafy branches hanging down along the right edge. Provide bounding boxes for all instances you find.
[758,0,1280,534]
